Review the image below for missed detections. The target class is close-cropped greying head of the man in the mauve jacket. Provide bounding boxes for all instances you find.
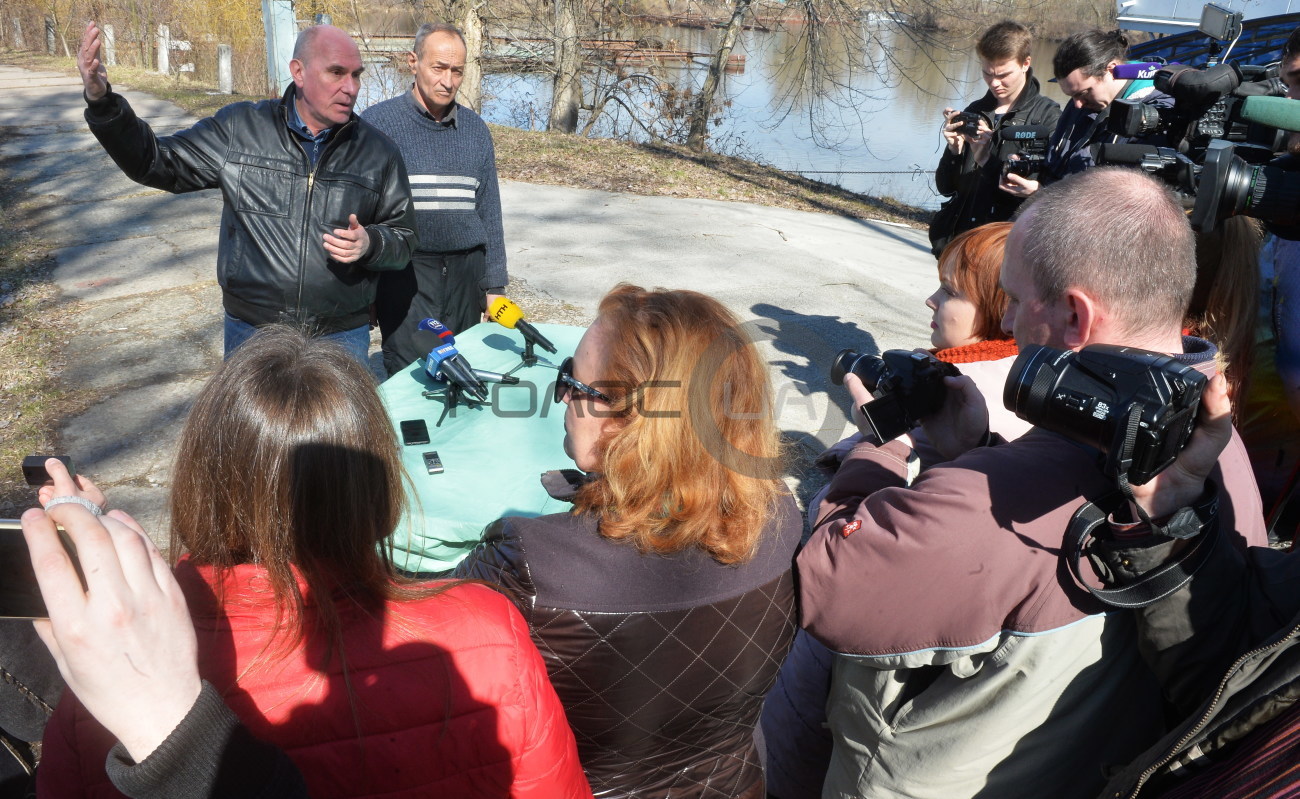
[1018,166,1196,333]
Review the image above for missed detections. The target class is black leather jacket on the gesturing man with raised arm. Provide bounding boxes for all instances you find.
[86,84,416,333]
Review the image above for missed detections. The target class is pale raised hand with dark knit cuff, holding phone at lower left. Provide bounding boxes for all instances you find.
[22,461,202,763]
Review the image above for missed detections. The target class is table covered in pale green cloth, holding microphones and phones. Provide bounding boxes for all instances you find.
[380,323,584,573]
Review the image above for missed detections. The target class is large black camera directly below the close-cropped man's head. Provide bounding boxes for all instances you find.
[1002,344,1206,486]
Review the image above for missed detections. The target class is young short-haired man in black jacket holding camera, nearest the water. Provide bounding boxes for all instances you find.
[930,22,1061,257]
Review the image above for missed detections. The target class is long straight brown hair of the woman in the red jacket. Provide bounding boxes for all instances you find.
[172,326,441,660]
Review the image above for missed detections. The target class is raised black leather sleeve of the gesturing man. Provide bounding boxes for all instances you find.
[86,92,227,194]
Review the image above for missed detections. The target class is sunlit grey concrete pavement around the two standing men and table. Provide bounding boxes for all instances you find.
[0,65,936,539]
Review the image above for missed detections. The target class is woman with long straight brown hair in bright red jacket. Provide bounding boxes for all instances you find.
[39,327,590,799]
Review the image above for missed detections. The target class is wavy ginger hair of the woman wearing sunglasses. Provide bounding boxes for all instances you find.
[576,283,784,564]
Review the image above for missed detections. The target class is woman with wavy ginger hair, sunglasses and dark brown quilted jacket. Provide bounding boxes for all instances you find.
[458,285,802,798]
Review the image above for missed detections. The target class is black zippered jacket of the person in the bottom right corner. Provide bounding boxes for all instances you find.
[1093,496,1300,799]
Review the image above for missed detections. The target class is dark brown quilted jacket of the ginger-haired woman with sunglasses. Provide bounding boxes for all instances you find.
[456,496,803,799]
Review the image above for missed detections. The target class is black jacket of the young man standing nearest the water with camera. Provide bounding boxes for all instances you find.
[930,69,1061,256]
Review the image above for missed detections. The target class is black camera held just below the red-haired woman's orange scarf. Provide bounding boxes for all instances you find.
[831,349,961,443]
